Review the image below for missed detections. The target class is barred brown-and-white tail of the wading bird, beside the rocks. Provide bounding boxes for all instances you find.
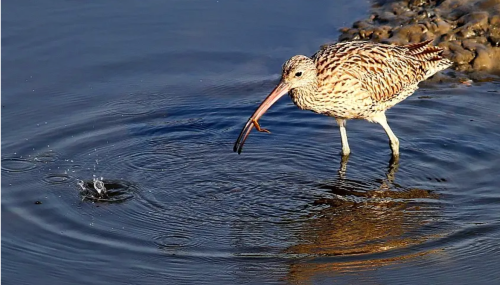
[405,40,453,79]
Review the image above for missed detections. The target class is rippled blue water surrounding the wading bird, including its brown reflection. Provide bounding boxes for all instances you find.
[2,0,500,284]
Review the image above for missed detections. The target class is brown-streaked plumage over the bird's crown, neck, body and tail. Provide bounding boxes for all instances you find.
[283,41,451,120]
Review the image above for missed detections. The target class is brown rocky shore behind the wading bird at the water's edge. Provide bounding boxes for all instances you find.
[339,0,500,79]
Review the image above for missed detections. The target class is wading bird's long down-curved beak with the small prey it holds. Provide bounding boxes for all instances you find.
[233,80,289,154]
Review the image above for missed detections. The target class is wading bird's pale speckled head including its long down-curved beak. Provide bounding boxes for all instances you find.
[234,55,317,153]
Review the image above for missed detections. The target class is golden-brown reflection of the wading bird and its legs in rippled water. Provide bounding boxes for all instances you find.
[287,158,439,281]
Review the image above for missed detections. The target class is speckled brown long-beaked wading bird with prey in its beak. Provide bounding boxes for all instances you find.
[233,39,452,158]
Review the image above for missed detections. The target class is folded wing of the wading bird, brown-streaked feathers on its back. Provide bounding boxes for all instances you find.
[313,42,425,102]
